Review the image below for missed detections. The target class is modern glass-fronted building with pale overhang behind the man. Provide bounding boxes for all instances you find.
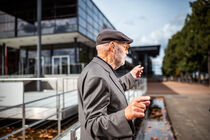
[0,0,115,75]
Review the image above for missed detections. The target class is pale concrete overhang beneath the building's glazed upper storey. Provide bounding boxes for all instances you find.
[0,32,95,49]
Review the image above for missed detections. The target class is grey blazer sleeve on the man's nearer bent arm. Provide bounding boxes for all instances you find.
[83,77,132,139]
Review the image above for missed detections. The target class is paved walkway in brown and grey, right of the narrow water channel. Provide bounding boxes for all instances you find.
[147,82,210,140]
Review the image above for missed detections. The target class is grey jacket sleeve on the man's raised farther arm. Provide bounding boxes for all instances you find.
[119,72,135,91]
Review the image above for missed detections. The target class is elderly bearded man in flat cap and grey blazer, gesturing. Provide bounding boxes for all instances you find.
[78,29,150,140]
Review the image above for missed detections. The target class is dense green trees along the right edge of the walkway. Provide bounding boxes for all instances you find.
[162,0,210,83]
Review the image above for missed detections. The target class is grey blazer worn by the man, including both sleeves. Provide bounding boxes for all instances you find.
[78,57,135,140]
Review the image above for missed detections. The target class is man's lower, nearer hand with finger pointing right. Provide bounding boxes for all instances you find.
[125,96,150,120]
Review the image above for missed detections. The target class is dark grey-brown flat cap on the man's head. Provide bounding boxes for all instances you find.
[96,29,133,46]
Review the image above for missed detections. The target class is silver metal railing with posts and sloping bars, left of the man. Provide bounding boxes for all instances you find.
[0,78,77,140]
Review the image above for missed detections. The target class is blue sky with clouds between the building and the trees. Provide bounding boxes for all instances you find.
[92,0,193,74]
